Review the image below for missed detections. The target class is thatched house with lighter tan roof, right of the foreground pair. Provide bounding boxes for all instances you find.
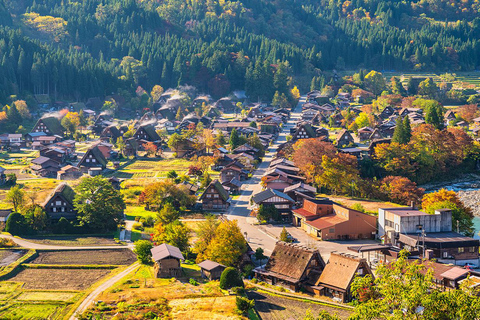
[312,252,374,302]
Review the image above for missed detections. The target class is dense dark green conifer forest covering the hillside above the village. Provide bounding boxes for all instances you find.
[0,0,480,103]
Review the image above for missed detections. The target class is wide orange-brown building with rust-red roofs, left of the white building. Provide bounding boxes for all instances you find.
[293,198,377,240]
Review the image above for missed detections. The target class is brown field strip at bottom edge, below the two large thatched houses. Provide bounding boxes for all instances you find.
[247,291,351,320]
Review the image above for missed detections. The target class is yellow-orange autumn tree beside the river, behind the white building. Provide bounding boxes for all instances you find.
[422,189,474,236]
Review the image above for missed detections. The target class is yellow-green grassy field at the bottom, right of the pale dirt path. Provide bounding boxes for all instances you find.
[82,265,245,320]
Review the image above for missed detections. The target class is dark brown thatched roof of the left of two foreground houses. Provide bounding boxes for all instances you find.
[265,241,323,281]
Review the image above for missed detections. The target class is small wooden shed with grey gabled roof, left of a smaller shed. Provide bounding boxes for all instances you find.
[151,243,185,278]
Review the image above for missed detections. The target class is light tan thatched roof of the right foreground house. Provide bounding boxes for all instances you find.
[316,252,370,290]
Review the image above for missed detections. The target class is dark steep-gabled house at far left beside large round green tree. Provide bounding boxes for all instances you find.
[42,183,76,220]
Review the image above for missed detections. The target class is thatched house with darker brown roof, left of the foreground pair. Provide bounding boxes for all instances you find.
[253,241,325,292]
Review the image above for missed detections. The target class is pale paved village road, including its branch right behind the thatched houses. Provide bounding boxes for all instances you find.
[227,96,376,260]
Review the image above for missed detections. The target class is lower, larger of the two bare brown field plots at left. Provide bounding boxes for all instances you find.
[9,269,110,290]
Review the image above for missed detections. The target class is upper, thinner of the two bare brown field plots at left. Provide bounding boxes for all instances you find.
[30,248,137,265]
